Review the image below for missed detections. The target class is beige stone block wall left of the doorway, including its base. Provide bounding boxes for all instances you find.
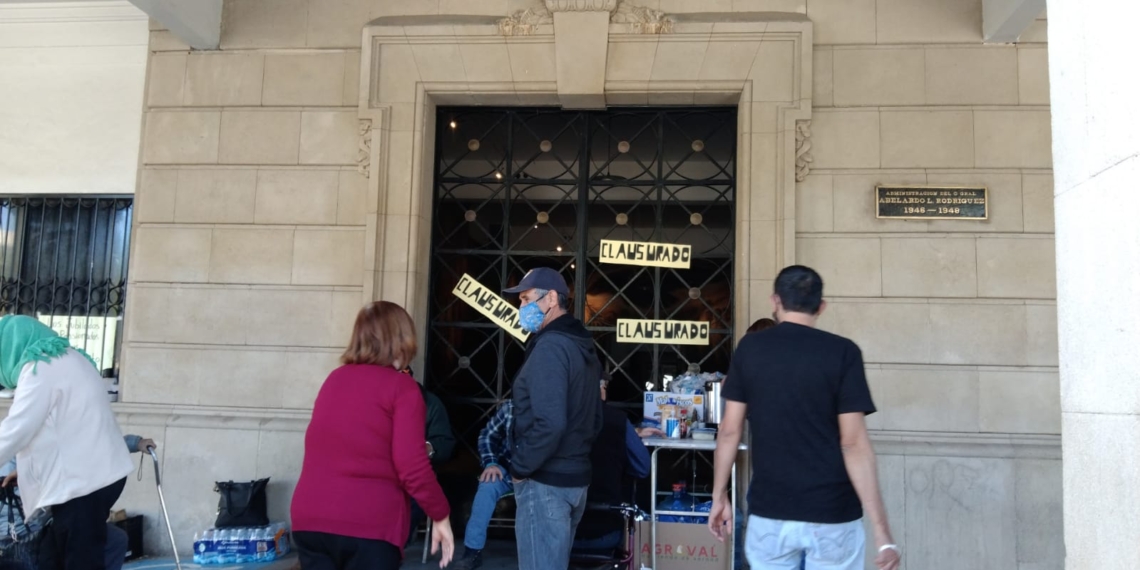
[117,1,371,553]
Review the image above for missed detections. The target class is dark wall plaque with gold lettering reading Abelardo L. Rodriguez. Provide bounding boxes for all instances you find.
[874,186,990,220]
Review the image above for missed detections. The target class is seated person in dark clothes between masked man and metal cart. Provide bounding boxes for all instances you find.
[573,373,663,551]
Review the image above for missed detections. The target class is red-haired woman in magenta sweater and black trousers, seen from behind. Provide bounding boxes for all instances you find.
[292,301,455,570]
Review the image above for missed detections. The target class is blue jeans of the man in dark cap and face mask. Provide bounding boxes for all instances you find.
[514,479,586,570]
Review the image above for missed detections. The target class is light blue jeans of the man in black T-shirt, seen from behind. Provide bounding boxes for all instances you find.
[744,516,866,570]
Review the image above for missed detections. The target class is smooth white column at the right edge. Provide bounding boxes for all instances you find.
[1049,0,1140,570]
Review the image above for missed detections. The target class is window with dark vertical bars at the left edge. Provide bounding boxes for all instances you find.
[0,195,133,375]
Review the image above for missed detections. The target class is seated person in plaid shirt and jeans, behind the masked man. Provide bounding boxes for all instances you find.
[450,400,514,570]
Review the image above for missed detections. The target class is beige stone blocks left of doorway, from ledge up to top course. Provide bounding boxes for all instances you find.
[130,44,365,408]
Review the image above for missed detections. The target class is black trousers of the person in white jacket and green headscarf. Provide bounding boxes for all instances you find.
[40,478,127,570]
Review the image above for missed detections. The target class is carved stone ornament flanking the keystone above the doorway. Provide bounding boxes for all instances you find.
[499,0,673,35]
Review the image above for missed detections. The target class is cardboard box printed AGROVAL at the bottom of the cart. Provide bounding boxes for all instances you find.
[637,521,728,570]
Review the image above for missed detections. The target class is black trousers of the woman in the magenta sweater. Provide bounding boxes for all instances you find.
[293,530,400,570]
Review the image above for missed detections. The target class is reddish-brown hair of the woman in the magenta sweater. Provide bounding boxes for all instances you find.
[341,301,416,369]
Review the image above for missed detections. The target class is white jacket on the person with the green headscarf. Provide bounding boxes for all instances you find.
[0,350,132,516]
